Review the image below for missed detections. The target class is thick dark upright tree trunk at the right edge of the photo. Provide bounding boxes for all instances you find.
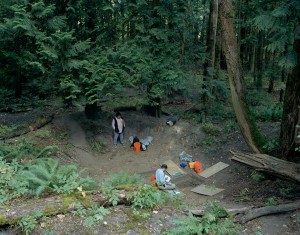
[280,24,300,160]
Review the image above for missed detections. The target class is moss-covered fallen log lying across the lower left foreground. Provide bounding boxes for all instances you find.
[0,191,128,226]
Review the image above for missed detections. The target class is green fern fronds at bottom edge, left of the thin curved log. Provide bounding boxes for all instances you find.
[164,202,238,235]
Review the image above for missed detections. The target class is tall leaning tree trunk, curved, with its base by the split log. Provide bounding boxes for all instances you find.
[219,0,262,153]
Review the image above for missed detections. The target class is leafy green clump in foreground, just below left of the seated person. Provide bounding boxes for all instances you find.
[127,184,170,209]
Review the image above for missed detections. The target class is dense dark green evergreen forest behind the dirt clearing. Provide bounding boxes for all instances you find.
[0,0,300,159]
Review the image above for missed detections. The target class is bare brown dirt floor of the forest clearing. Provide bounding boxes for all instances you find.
[0,104,300,235]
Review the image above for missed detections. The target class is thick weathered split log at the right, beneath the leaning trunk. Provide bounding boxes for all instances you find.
[231,151,300,184]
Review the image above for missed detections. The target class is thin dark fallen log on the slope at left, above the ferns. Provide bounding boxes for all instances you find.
[0,115,54,140]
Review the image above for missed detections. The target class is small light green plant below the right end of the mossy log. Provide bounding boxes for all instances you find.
[72,203,110,227]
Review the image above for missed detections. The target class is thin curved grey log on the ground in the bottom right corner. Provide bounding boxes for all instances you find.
[235,201,300,224]
